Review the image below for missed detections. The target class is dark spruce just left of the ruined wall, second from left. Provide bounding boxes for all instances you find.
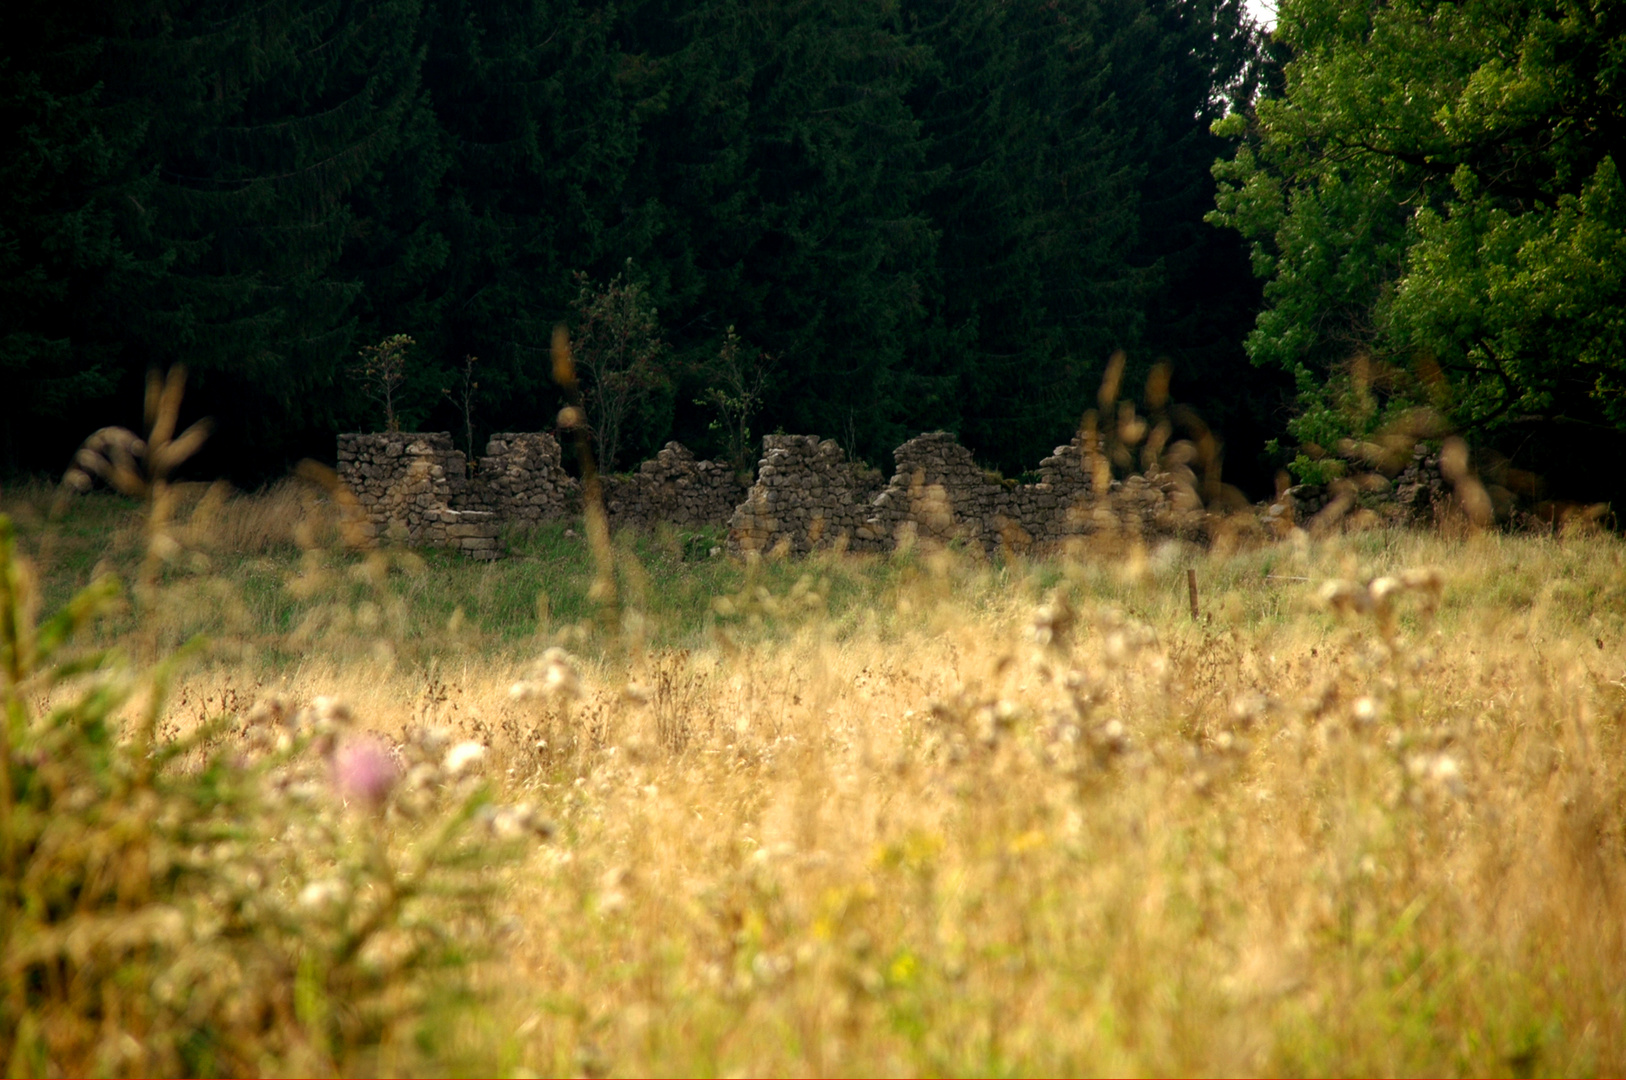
[104,0,418,455]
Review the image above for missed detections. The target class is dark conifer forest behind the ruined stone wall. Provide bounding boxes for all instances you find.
[0,0,1291,485]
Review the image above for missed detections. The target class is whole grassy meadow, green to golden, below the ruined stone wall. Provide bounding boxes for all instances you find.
[0,480,1626,1075]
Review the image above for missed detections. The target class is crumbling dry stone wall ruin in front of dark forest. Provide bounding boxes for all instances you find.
[338,431,1447,558]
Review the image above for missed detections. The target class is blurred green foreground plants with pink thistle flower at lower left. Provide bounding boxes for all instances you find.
[0,372,546,1075]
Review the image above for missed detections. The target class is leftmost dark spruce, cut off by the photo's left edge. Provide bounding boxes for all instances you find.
[0,0,152,472]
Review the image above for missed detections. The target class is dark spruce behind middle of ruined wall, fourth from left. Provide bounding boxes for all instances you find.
[626,0,935,460]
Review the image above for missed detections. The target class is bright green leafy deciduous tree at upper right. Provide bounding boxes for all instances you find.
[1211,0,1626,470]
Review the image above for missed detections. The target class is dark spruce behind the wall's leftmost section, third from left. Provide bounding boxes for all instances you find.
[421,0,640,449]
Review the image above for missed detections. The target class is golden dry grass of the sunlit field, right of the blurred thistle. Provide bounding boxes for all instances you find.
[114,507,1626,1075]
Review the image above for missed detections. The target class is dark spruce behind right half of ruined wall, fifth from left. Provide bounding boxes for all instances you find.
[906,0,1153,468]
